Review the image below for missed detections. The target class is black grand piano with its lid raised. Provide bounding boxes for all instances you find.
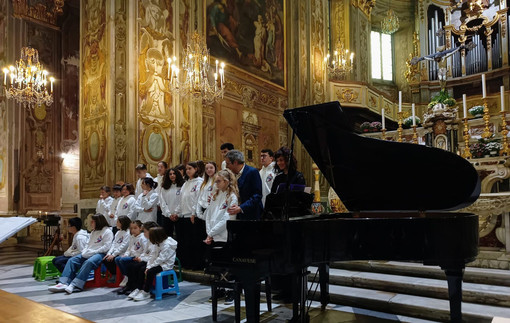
[212,102,480,322]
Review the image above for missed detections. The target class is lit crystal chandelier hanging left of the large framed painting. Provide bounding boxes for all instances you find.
[167,31,225,104]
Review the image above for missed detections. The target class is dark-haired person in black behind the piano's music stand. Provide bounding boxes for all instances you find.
[271,147,306,193]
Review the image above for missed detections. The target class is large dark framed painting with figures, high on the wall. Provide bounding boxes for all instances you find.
[204,0,287,89]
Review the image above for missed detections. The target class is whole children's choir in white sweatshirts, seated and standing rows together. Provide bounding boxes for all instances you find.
[49,143,298,301]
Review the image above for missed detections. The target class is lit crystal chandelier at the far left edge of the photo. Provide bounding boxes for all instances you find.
[2,46,55,107]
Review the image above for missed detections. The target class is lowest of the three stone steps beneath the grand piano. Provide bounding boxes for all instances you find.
[306,285,510,323]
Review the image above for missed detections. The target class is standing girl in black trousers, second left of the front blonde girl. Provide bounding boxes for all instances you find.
[171,162,204,269]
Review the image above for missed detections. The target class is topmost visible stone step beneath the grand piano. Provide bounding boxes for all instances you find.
[331,261,510,287]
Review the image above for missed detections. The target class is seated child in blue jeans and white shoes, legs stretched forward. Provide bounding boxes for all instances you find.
[48,214,113,294]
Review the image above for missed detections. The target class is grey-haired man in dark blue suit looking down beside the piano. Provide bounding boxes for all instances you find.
[225,150,263,220]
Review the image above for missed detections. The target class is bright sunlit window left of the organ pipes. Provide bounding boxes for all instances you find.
[370,31,393,81]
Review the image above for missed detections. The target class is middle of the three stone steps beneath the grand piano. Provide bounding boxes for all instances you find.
[309,267,510,306]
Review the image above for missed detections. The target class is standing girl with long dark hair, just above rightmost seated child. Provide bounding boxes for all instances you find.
[159,168,184,237]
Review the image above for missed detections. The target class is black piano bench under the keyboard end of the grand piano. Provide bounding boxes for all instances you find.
[209,272,272,323]
